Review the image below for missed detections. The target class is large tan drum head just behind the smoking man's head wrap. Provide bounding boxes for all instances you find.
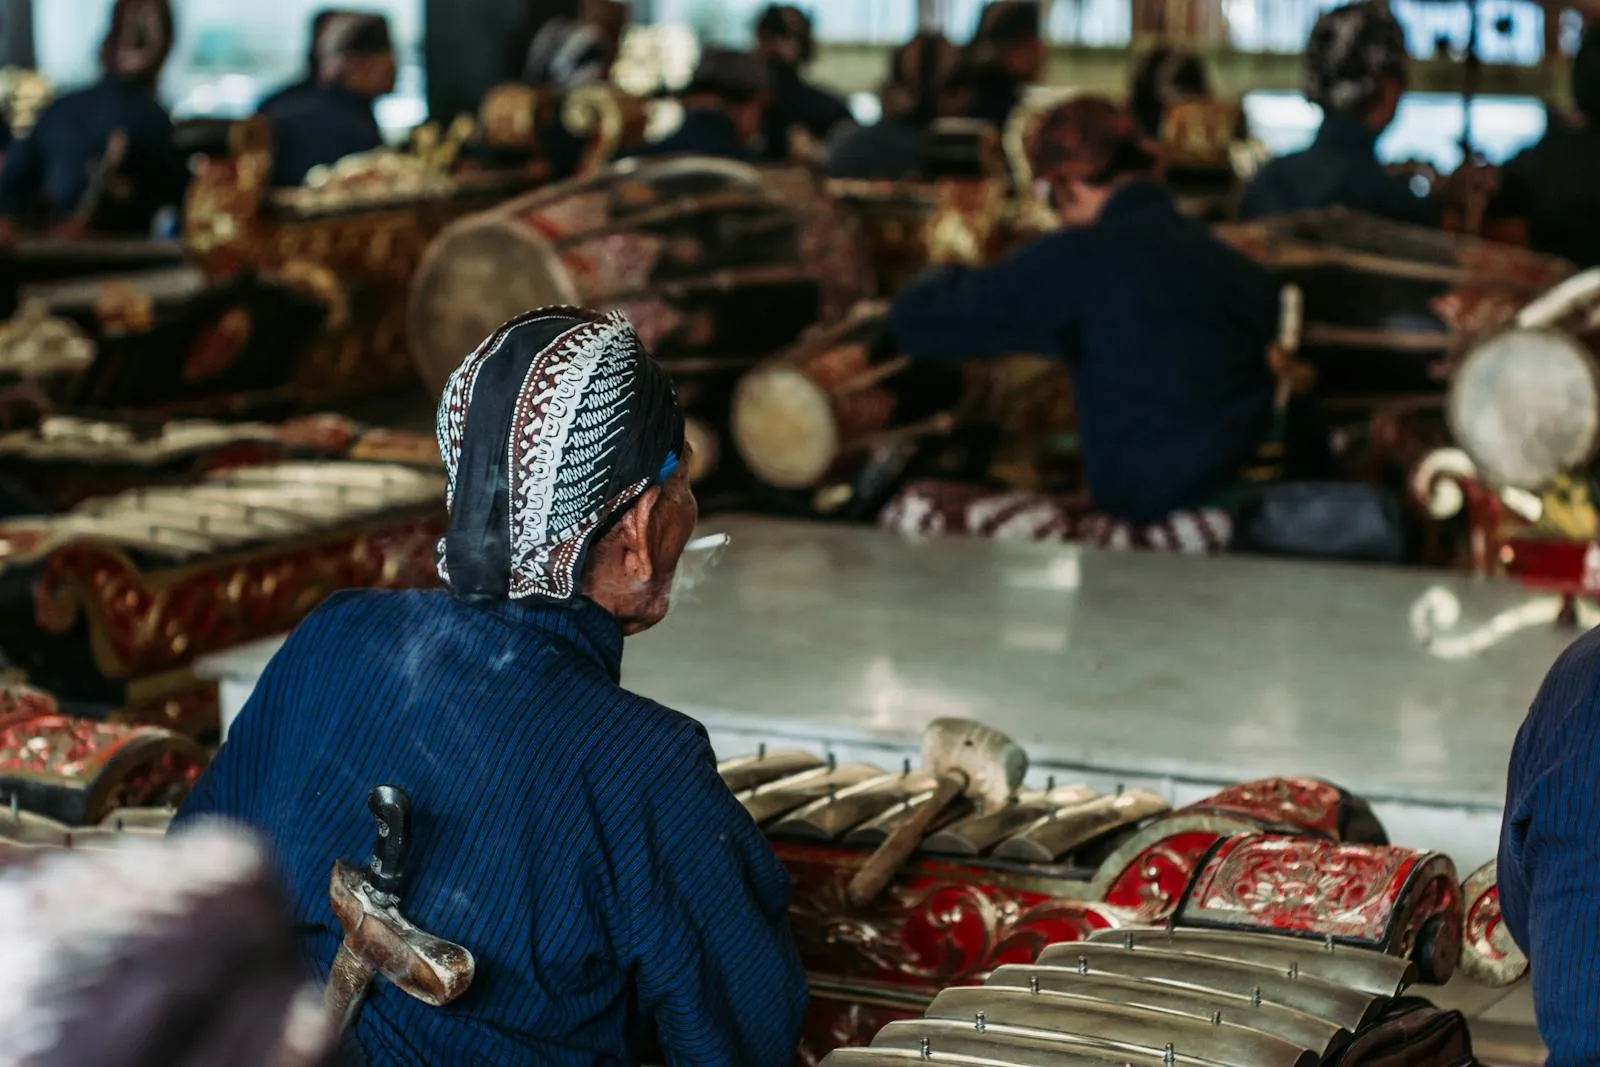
[406,214,579,395]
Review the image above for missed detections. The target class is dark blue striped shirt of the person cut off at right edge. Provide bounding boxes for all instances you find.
[1499,630,1600,1067]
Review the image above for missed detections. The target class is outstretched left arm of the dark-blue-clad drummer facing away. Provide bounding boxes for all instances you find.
[888,234,1090,360]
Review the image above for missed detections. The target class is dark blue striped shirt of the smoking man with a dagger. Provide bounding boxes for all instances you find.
[179,590,806,1067]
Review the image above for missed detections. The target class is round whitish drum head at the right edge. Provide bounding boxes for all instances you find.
[1448,330,1600,490]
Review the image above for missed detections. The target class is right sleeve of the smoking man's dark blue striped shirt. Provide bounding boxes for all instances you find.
[611,726,806,1067]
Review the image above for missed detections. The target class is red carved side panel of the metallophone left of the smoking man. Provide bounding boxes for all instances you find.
[34,517,443,678]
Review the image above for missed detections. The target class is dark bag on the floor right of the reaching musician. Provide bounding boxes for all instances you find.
[1234,482,1405,563]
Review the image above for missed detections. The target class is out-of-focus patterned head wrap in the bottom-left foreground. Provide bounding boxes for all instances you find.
[0,825,336,1067]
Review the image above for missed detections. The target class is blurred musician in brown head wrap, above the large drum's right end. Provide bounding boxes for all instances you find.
[827,34,973,181]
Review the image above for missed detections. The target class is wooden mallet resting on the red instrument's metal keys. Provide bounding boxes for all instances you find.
[850,718,1027,907]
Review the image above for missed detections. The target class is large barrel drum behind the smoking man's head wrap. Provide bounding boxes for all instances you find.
[408,157,864,390]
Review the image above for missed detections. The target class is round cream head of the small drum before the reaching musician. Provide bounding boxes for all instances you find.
[733,365,838,490]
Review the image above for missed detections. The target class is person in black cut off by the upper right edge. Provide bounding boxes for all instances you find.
[1490,27,1600,267]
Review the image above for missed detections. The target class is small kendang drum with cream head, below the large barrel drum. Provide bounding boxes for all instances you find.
[733,302,976,502]
